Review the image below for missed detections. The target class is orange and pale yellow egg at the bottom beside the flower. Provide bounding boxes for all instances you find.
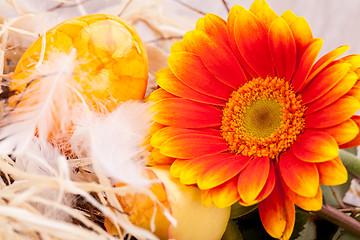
[105,166,231,240]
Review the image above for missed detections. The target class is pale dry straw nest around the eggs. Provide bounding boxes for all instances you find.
[0,0,205,240]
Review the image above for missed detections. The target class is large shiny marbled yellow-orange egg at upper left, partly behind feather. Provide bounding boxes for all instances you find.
[9,14,148,145]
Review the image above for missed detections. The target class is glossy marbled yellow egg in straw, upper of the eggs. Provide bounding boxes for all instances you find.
[9,14,148,110]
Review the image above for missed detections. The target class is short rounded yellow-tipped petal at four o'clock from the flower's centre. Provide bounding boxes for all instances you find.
[289,131,339,162]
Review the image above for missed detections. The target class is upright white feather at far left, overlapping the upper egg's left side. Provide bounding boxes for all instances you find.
[0,50,76,155]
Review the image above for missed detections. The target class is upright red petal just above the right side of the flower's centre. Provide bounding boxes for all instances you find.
[269,18,296,82]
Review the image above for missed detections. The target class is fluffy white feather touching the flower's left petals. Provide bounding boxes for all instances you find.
[70,101,152,186]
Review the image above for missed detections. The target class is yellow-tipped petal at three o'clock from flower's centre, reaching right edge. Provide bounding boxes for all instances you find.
[305,96,360,128]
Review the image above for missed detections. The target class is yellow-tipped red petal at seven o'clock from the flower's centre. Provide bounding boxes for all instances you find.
[197,155,250,189]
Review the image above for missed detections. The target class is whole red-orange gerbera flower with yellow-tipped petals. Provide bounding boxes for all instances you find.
[150,1,360,239]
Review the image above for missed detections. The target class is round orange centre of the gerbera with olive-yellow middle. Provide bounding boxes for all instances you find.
[221,77,305,158]
